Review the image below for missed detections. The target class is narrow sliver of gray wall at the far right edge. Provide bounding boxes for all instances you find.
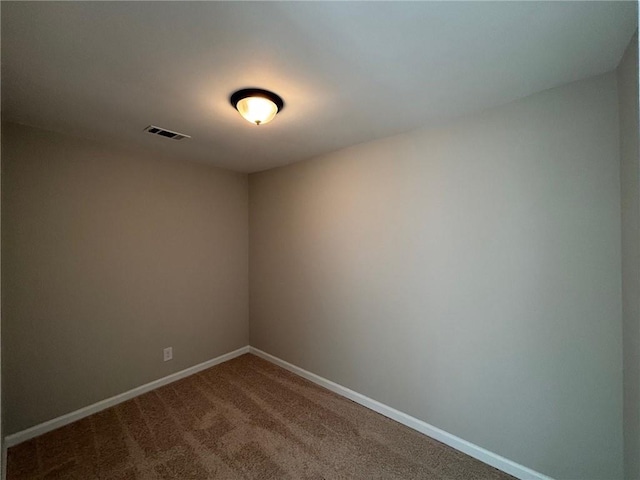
[617,31,640,479]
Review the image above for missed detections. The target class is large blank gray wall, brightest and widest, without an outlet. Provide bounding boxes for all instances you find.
[249,73,623,480]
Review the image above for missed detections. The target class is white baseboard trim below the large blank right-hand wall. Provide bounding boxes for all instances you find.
[249,347,553,480]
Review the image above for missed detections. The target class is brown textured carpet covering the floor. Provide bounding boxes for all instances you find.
[8,355,513,480]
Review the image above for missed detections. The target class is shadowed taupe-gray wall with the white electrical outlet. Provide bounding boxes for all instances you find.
[2,124,248,434]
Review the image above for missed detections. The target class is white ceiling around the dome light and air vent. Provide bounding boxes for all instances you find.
[1,1,637,172]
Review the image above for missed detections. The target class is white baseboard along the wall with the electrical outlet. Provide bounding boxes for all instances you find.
[3,346,249,448]
